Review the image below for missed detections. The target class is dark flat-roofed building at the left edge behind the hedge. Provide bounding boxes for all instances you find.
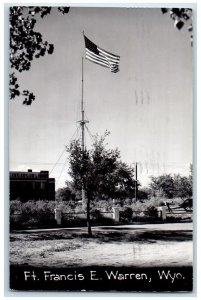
[10,169,55,201]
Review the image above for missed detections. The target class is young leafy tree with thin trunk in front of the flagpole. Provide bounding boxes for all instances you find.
[67,132,135,236]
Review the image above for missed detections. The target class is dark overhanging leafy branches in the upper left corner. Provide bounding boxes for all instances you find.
[9,6,69,105]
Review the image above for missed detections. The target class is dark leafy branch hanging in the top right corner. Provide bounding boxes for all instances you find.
[161,8,193,46]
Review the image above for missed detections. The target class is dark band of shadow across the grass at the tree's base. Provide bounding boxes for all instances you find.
[10,228,192,243]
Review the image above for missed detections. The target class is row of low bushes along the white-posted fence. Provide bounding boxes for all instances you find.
[10,197,185,229]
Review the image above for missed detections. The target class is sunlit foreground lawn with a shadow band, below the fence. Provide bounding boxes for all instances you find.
[10,223,193,267]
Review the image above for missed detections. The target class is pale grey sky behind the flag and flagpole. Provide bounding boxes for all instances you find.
[9,7,193,188]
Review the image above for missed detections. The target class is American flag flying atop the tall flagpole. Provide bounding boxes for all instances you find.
[84,35,120,73]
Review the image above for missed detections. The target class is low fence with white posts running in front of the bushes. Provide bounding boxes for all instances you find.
[10,206,192,229]
